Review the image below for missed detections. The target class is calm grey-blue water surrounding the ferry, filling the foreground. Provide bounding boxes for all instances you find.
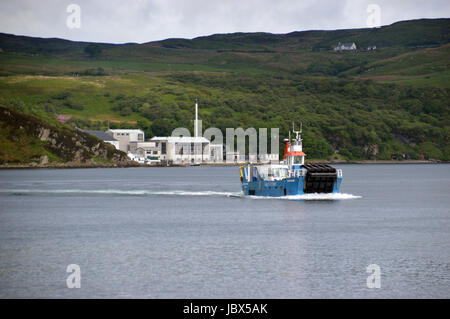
[0,165,450,298]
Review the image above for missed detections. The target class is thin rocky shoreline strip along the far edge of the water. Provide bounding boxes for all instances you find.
[0,160,444,170]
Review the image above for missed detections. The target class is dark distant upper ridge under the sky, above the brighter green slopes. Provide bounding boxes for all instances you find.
[0,19,450,75]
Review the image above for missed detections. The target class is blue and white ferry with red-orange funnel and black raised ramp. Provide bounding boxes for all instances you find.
[240,126,342,197]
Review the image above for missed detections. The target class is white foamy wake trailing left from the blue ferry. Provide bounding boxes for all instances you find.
[0,189,361,201]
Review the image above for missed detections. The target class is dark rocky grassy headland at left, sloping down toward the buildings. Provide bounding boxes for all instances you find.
[0,107,133,167]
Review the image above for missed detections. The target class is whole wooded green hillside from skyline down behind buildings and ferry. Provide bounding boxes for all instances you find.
[0,19,450,160]
